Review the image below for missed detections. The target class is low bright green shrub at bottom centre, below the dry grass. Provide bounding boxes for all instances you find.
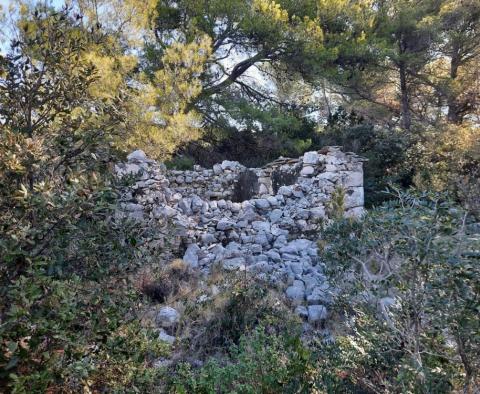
[171,326,315,394]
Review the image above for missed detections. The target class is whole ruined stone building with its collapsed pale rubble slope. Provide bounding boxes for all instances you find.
[116,147,364,323]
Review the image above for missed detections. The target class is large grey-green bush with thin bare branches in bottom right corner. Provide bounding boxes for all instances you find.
[320,193,480,393]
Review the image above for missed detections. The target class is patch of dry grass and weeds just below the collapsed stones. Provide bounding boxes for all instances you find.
[138,260,299,364]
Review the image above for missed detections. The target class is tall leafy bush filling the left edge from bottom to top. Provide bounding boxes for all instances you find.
[0,8,165,393]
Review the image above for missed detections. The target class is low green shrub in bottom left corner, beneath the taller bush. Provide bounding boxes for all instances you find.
[0,262,171,393]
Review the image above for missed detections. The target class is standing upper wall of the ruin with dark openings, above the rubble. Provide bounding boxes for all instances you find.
[165,147,363,216]
